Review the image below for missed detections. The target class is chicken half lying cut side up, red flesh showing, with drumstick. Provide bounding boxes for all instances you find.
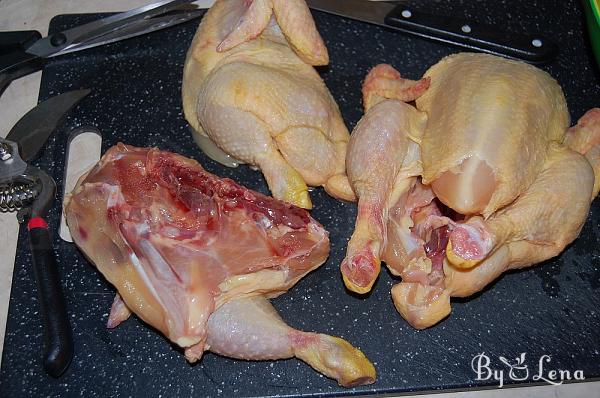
[66,144,375,386]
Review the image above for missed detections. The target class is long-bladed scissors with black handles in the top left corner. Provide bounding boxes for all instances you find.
[0,0,204,94]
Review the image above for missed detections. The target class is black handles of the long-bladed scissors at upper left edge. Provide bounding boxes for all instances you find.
[0,30,43,95]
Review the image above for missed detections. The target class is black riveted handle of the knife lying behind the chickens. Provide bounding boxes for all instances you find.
[385,5,558,64]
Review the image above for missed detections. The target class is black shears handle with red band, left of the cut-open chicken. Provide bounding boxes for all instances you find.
[27,217,73,377]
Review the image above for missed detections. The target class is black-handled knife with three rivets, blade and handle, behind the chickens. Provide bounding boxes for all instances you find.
[306,0,558,64]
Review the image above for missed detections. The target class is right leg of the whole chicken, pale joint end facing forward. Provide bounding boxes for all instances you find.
[444,145,598,297]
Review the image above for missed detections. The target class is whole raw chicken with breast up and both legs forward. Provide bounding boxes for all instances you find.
[341,53,600,328]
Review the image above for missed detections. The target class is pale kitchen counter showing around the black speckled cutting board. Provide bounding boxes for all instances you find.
[0,0,600,398]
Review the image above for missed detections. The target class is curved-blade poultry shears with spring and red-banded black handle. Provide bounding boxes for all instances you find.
[0,90,90,377]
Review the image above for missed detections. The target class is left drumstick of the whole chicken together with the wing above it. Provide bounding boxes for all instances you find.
[341,65,428,293]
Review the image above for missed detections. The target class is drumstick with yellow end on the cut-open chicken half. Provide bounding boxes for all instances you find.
[207,296,376,387]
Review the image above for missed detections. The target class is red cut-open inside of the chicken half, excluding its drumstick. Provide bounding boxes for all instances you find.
[66,144,329,348]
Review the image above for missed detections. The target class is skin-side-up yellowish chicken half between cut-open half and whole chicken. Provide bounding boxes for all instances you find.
[182,0,355,209]
